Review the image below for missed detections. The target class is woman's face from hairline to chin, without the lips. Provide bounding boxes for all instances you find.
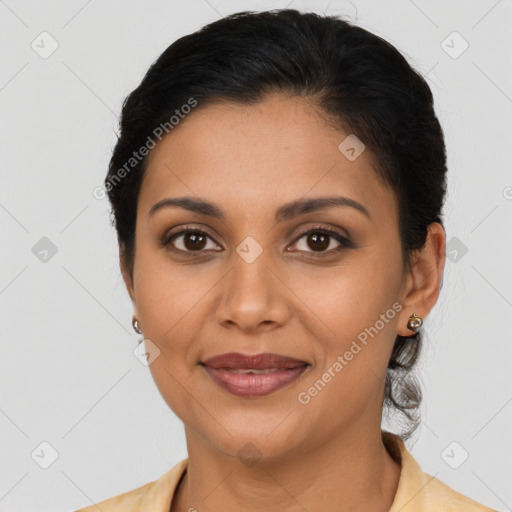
[123,95,418,464]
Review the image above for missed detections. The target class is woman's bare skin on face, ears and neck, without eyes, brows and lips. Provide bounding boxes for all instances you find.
[120,94,445,512]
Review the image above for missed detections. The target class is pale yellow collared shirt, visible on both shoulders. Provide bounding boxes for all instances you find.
[75,431,497,512]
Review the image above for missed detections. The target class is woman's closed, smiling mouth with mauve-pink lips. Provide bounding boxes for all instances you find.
[200,352,310,398]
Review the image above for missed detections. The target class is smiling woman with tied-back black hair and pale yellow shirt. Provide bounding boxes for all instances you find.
[75,10,492,512]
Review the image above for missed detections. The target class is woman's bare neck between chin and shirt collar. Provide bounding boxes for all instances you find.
[171,425,400,512]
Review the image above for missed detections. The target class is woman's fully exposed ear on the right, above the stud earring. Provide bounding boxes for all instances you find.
[397,222,446,336]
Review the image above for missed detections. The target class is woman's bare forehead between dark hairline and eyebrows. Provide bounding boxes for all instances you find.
[139,94,395,223]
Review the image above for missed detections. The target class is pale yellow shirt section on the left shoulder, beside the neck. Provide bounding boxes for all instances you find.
[75,459,188,512]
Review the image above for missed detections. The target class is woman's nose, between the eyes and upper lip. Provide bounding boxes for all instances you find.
[215,246,291,333]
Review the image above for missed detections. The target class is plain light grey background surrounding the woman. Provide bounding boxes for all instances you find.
[0,0,512,512]
